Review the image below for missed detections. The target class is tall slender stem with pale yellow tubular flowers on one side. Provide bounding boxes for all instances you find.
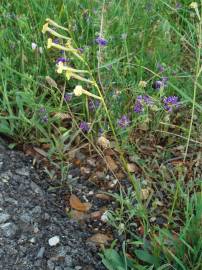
[42,19,141,200]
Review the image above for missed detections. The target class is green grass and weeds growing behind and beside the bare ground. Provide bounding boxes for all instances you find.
[0,0,202,270]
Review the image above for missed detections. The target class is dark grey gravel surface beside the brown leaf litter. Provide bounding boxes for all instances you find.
[0,145,105,270]
